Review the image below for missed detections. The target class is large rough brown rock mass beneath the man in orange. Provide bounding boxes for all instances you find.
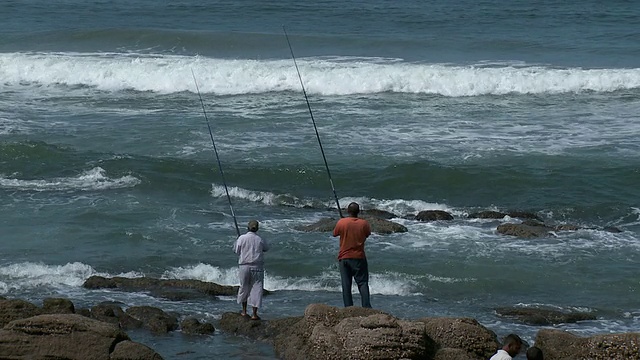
[220,304,499,360]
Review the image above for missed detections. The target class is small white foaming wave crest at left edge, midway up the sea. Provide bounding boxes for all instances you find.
[0,167,140,191]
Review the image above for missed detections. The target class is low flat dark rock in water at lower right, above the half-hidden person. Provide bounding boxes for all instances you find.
[496,307,596,325]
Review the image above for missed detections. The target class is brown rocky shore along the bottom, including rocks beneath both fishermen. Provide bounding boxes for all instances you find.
[0,277,640,360]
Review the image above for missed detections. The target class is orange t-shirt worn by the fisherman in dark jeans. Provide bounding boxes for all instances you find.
[333,217,371,260]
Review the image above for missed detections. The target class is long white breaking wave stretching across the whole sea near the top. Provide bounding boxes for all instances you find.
[0,52,640,97]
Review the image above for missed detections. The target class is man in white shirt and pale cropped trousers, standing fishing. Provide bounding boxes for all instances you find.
[233,220,269,320]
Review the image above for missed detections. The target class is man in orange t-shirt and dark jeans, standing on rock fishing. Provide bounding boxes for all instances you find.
[333,202,371,308]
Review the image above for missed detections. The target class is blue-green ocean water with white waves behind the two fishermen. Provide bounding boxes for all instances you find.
[0,0,640,359]
